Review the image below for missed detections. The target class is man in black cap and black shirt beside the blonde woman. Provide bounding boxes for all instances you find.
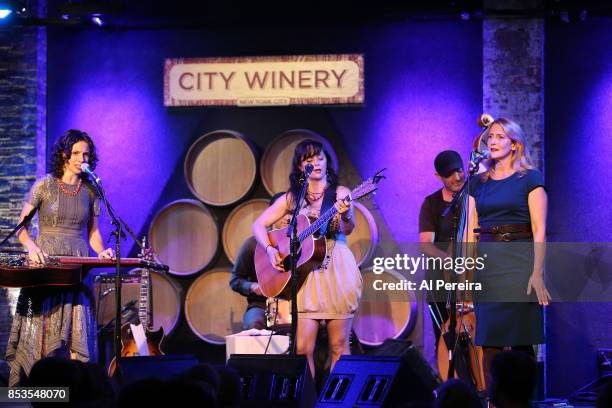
[419,150,465,348]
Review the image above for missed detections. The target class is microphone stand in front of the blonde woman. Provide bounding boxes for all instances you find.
[442,152,483,379]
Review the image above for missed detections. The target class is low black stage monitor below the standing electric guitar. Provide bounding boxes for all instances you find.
[118,355,200,384]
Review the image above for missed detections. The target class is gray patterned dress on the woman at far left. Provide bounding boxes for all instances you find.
[6,175,100,386]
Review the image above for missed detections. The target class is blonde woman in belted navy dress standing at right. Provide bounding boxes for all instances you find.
[468,118,550,385]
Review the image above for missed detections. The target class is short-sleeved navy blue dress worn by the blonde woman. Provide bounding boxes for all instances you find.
[470,169,544,347]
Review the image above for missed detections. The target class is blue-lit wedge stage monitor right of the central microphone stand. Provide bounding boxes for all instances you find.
[317,340,440,407]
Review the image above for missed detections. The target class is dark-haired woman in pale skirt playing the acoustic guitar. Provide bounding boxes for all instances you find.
[253,140,362,375]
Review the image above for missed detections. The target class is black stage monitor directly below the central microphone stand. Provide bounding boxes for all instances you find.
[228,354,317,408]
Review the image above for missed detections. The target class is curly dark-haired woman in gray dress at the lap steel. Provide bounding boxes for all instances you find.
[6,130,114,386]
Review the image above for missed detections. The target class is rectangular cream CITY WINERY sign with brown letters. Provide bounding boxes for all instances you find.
[164,54,364,106]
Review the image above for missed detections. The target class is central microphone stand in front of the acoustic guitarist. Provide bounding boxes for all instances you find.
[287,166,312,355]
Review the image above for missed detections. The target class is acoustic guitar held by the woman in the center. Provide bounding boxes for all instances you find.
[255,169,385,299]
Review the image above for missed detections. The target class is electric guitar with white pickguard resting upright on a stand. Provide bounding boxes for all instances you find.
[108,239,164,377]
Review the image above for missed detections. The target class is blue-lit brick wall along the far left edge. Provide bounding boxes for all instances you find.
[0,9,47,376]
